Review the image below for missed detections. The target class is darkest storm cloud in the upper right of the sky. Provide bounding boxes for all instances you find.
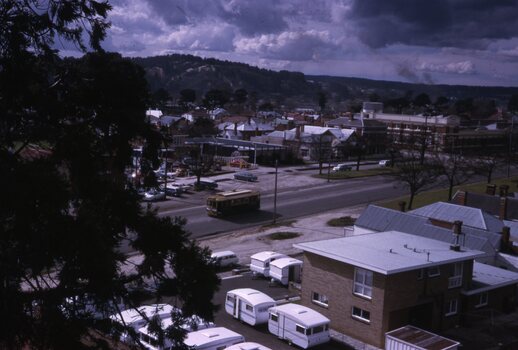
[348,0,518,48]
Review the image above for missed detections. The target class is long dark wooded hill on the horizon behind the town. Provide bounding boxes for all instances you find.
[133,54,518,106]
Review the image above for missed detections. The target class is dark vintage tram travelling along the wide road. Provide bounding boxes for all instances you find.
[207,190,261,216]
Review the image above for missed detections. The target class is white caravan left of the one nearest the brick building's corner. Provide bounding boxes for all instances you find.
[225,288,275,326]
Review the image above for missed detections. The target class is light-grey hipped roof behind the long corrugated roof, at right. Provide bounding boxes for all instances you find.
[409,202,504,232]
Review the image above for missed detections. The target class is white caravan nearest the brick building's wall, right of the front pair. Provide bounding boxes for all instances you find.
[268,304,330,349]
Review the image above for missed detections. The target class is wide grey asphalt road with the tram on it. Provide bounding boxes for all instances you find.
[159,176,406,238]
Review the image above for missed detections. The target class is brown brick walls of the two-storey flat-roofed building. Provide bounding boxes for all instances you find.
[302,252,473,347]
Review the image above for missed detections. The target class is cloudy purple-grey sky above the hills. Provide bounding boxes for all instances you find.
[95,0,518,86]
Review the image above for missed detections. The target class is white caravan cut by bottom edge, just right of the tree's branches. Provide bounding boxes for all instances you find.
[183,327,245,350]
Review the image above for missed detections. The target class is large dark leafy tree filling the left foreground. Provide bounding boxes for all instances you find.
[0,0,219,350]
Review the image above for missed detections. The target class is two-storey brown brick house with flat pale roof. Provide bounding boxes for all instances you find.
[294,231,494,347]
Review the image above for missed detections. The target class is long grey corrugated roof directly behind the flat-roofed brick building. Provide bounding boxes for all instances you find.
[355,205,501,255]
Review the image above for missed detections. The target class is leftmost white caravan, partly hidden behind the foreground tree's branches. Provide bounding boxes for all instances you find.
[110,304,174,341]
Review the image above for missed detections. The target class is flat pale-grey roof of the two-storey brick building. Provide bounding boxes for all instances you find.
[294,231,484,275]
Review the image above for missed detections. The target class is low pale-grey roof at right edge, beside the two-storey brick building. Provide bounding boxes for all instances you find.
[464,261,518,295]
